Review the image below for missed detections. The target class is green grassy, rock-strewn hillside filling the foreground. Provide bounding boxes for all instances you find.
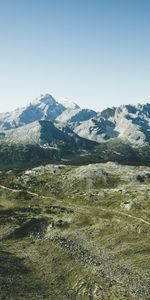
[0,164,150,300]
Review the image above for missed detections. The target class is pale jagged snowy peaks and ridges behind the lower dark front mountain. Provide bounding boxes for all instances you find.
[0,94,150,146]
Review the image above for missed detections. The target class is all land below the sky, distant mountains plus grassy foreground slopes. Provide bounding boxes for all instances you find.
[0,94,150,300]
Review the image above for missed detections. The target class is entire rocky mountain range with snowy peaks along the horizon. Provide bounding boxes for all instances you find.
[0,94,150,146]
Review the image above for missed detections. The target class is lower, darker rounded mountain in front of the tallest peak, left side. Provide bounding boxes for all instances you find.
[0,120,96,151]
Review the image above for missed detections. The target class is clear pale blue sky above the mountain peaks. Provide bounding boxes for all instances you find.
[0,0,150,112]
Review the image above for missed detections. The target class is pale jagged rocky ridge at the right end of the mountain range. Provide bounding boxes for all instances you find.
[74,104,150,145]
